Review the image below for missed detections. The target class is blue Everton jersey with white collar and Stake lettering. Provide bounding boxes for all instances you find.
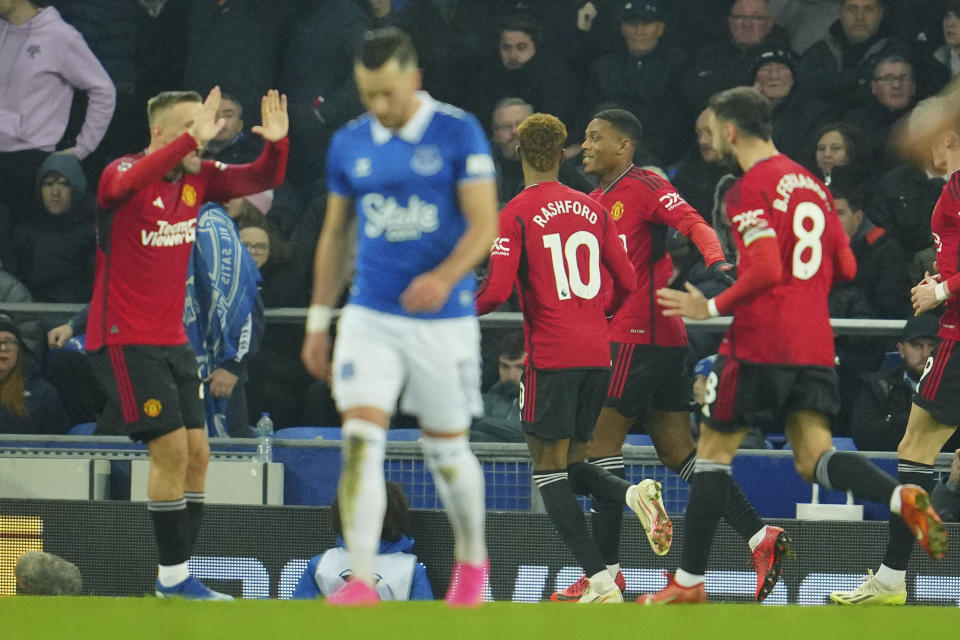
[327,91,495,318]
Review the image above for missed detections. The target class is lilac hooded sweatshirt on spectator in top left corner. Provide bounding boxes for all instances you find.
[0,7,116,160]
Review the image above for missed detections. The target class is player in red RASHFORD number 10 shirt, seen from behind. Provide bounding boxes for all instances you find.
[477,113,653,602]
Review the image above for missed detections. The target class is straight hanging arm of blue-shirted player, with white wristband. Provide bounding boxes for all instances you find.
[300,193,352,379]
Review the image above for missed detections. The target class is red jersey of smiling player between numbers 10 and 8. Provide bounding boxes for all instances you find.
[590,166,723,346]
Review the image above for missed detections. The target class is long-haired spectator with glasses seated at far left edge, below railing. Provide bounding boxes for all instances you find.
[0,313,70,434]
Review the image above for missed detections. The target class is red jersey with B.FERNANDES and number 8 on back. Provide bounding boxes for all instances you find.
[717,154,856,367]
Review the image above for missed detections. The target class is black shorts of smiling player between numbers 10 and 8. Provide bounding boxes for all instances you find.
[603,342,693,418]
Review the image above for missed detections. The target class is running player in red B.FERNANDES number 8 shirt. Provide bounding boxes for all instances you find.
[638,87,946,604]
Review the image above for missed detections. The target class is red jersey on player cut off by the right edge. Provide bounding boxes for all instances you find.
[930,171,960,340]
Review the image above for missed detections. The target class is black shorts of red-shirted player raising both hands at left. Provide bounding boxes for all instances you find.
[88,345,204,442]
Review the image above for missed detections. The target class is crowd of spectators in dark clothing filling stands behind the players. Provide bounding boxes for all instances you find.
[0,0,960,450]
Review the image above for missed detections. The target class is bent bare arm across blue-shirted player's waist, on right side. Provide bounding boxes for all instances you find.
[400,180,497,313]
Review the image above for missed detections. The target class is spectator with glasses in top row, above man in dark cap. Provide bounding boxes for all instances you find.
[676,0,790,110]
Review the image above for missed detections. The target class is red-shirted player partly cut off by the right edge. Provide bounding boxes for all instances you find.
[830,95,960,605]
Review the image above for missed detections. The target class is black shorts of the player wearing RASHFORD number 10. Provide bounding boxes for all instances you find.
[520,367,610,442]
